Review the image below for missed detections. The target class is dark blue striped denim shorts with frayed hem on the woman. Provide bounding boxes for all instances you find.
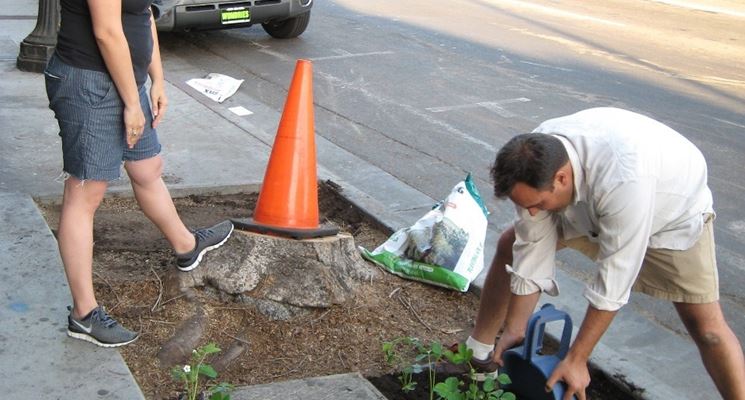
[44,54,161,181]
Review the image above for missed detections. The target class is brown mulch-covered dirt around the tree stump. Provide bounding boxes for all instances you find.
[40,187,628,399]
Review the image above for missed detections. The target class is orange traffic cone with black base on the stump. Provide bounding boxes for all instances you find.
[233,60,339,239]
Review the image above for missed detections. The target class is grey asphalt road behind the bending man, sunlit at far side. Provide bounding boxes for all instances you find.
[161,0,745,342]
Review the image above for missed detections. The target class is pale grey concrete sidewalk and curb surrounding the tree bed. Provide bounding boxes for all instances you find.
[0,0,716,400]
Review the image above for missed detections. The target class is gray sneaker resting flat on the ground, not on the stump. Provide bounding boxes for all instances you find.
[67,306,139,347]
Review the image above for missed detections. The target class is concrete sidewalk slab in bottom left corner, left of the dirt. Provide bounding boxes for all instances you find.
[0,192,143,400]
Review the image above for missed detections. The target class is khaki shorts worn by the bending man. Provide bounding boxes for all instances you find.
[559,217,719,304]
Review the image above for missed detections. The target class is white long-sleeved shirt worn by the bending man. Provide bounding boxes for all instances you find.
[509,108,713,311]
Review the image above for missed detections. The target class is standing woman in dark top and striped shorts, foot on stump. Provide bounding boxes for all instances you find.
[44,0,233,347]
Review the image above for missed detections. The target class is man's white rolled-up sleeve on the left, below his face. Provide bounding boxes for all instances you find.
[507,207,559,296]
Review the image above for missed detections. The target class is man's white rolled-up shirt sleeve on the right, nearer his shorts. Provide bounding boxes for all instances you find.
[584,178,655,311]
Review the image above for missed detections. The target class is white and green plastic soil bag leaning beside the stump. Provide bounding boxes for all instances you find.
[360,174,489,292]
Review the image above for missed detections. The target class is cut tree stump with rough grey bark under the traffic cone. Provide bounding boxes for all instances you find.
[165,230,378,319]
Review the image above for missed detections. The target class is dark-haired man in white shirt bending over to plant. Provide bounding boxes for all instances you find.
[466,108,745,400]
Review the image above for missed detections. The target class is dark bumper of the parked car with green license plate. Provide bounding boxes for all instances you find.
[153,0,313,31]
